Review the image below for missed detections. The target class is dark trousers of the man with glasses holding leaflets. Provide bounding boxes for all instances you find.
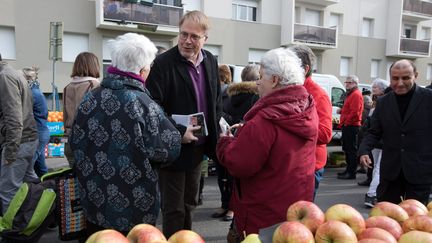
[159,146,204,239]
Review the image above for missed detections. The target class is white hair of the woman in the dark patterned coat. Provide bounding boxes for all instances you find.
[108,33,157,73]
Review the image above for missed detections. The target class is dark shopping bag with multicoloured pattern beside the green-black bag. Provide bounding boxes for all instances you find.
[51,168,86,241]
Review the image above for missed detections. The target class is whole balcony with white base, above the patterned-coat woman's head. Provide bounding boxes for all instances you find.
[96,0,183,34]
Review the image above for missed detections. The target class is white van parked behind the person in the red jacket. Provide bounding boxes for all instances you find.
[312,73,345,139]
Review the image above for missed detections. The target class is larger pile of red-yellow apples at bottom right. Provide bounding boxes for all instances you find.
[242,199,432,243]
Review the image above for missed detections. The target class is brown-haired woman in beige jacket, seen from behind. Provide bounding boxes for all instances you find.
[63,52,99,167]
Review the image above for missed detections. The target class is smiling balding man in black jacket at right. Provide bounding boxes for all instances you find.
[359,60,432,204]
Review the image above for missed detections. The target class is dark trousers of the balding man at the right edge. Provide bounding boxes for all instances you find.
[377,171,432,205]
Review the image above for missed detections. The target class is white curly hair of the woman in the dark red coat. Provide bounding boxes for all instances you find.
[261,48,304,86]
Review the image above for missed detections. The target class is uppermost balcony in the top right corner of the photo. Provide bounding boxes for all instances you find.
[403,0,432,22]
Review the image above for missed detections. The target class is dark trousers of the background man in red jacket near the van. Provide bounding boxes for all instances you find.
[342,126,360,175]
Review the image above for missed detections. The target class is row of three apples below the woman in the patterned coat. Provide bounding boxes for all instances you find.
[86,224,204,243]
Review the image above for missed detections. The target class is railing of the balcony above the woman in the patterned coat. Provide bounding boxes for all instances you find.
[103,0,183,26]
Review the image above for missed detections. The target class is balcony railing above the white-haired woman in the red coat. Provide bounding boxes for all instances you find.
[294,24,337,46]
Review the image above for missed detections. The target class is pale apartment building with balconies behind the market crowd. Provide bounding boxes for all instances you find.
[0,0,432,93]
